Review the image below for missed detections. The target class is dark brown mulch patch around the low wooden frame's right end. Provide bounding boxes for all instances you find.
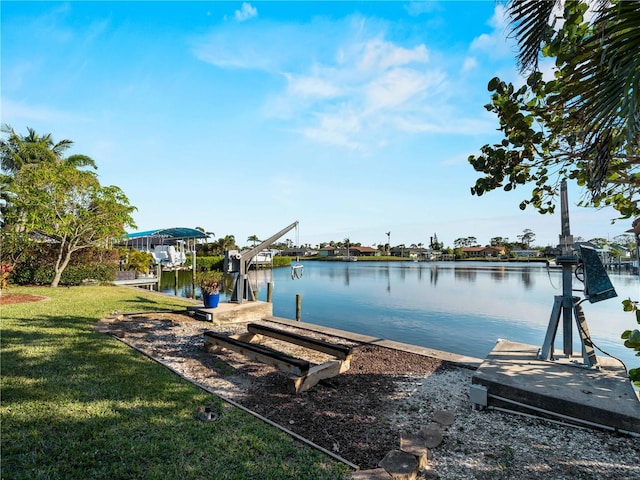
[242,345,447,468]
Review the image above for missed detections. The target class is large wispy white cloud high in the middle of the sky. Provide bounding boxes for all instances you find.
[194,8,504,152]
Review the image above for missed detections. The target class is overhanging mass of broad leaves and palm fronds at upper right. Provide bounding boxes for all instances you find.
[469,0,640,218]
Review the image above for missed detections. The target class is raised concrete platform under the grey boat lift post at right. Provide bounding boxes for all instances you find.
[471,340,640,434]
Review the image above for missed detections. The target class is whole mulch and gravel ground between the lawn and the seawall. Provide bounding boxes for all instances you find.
[97,314,640,479]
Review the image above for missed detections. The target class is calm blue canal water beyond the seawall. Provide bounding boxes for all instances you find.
[161,261,640,368]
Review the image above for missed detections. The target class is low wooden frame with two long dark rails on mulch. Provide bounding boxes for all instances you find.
[204,324,351,393]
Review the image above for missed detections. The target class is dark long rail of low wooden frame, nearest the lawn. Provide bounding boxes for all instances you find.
[204,332,311,376]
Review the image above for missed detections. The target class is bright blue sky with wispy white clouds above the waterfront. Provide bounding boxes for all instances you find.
[0,0,629,246]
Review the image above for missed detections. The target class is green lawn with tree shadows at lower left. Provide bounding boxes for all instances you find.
[0,286,349,480]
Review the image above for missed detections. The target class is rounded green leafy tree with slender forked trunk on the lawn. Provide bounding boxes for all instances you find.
[3,159,135,287]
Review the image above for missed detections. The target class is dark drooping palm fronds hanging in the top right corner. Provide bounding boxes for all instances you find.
[507,0,640,193]
